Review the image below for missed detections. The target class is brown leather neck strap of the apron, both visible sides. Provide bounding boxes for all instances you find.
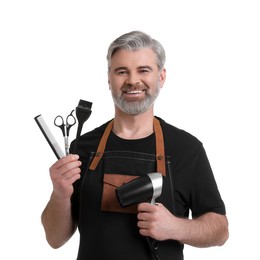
[89,118,166,176]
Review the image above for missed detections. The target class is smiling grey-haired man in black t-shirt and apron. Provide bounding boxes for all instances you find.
[42,31,228,260]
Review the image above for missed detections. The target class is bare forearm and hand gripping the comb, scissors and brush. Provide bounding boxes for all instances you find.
[42,155,81,248]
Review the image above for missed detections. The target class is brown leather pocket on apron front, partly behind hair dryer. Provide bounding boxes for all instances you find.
[101,173,139,214]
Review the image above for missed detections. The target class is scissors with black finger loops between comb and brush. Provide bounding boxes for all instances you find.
[54,110,76,155]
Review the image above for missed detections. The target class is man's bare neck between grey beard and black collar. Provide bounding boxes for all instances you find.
[113,109,154,139]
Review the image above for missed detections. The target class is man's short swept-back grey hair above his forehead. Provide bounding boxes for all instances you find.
[107,31,166,70]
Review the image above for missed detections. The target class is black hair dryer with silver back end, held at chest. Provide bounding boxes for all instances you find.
[116,172,163,207]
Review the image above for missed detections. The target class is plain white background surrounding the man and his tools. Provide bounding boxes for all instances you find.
[0,0,260,260]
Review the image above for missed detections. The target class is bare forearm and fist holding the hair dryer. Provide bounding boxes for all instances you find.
[137,203,229,247]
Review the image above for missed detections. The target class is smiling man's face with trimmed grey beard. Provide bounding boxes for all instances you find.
[108,48,165,115]
